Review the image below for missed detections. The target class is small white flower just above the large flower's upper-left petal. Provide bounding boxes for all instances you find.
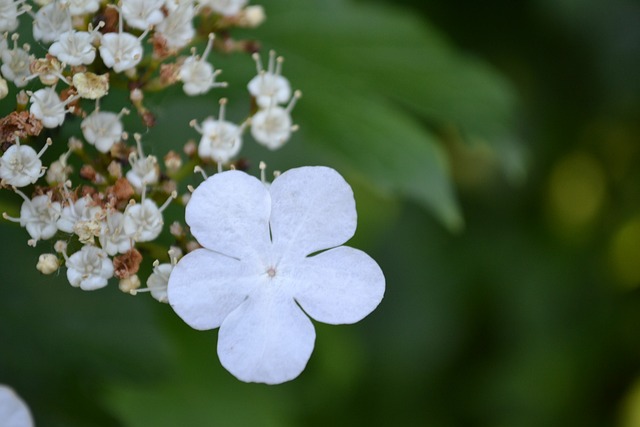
[191,98,247,164]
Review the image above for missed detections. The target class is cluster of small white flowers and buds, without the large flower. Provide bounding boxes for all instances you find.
[0,0,301,302]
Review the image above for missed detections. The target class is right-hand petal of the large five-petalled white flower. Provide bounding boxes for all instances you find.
[290,246,385,325]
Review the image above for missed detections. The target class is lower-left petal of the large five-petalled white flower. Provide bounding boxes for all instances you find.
[167,249,258,330]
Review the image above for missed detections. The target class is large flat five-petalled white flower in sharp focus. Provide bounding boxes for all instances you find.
[168,167,384,384]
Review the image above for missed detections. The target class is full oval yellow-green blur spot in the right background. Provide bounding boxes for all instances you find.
[549,153,606,232]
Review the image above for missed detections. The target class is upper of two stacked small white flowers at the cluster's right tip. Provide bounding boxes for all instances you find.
[247,50,291,108]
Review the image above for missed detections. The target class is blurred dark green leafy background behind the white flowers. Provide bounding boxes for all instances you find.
[0,0,640,427]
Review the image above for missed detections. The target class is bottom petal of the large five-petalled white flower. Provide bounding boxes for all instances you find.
[218,285,316,384]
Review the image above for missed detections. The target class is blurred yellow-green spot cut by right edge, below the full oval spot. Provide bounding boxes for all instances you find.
[609,216,640,290]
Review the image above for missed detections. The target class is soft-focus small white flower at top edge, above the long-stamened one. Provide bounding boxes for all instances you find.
[156,0,196,49]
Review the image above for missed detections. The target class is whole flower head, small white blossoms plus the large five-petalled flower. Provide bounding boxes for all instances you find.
[0,0,384,384]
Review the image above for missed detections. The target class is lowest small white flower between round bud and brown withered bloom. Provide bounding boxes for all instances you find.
[65,245,113,291]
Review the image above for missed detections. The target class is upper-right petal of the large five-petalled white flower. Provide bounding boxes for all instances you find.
[270,166,357,257]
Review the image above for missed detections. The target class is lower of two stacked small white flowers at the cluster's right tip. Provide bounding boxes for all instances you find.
[251,91,301,150]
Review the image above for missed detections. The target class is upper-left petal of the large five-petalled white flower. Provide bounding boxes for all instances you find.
[185,171,271,259]
